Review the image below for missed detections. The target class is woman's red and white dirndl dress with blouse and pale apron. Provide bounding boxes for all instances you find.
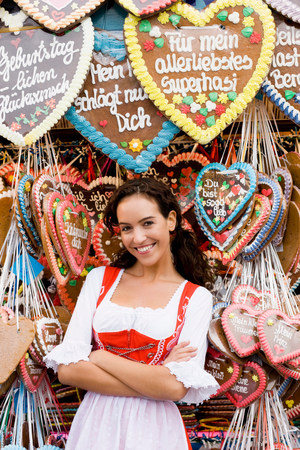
[45,267,219,450]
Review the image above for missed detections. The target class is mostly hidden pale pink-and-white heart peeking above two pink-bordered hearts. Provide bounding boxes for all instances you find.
[231,284,279,311]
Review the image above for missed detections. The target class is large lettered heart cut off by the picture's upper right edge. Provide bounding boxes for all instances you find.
[262,13,300,125]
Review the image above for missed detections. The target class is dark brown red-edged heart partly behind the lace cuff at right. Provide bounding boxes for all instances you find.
[204,346,242,397]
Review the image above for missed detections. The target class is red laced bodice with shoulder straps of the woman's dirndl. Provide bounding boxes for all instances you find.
[93,267,198,364]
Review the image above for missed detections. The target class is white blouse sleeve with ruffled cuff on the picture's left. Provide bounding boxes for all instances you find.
[44,267,104,372]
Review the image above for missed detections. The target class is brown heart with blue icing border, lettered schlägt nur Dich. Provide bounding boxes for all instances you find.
[66,32,179,173]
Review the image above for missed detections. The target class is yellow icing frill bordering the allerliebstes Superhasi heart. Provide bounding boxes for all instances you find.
[124,0,275,144]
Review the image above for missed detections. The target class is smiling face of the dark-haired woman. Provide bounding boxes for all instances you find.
[117,194,176,266]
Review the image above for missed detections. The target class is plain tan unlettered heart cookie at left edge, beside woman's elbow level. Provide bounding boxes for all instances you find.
[0,317,35,383]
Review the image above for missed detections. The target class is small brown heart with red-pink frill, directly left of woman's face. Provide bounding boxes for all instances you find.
[93,220,123,266]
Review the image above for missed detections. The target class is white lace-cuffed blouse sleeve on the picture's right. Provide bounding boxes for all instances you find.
[166,287,219,404]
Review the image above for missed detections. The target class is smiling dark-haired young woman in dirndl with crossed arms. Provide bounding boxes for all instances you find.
[45,179,218,450]
